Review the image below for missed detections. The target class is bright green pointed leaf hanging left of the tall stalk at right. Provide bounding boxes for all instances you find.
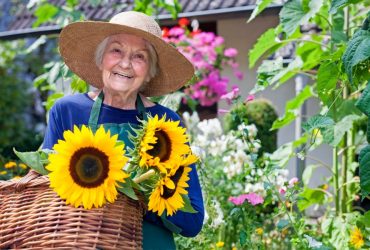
[316,61,340,106]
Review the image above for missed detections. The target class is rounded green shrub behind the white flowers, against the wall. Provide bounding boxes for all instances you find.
[224,99,278,153]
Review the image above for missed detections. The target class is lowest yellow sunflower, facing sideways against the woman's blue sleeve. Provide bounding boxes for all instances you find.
[148,154,198,216]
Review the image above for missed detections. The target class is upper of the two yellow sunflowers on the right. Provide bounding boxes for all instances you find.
[139,115,190,173]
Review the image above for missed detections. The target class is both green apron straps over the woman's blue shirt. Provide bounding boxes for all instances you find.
[88,91,148,127]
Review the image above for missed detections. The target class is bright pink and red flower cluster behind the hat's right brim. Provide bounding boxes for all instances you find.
[162,18,243,106]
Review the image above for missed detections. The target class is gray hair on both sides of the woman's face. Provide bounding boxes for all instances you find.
[95,36,158,81]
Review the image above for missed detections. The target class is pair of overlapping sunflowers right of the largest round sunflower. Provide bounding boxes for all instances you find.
[129,115,198,216]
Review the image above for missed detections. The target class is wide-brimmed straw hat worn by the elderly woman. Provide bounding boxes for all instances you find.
[59,11,194,96]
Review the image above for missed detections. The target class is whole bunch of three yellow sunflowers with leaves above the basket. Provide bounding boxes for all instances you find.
[18,115,198,216]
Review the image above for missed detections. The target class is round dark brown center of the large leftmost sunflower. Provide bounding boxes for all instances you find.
[69,147,109,188]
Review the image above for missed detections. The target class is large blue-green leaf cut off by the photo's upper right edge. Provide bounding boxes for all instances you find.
[342,12,370,85]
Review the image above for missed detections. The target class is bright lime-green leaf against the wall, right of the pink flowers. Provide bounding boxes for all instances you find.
[249,26,284,68]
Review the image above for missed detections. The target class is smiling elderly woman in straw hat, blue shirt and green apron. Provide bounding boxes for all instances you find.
[43,11,204,249]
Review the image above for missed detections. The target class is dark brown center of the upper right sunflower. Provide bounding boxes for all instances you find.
[148,130,171,162]
